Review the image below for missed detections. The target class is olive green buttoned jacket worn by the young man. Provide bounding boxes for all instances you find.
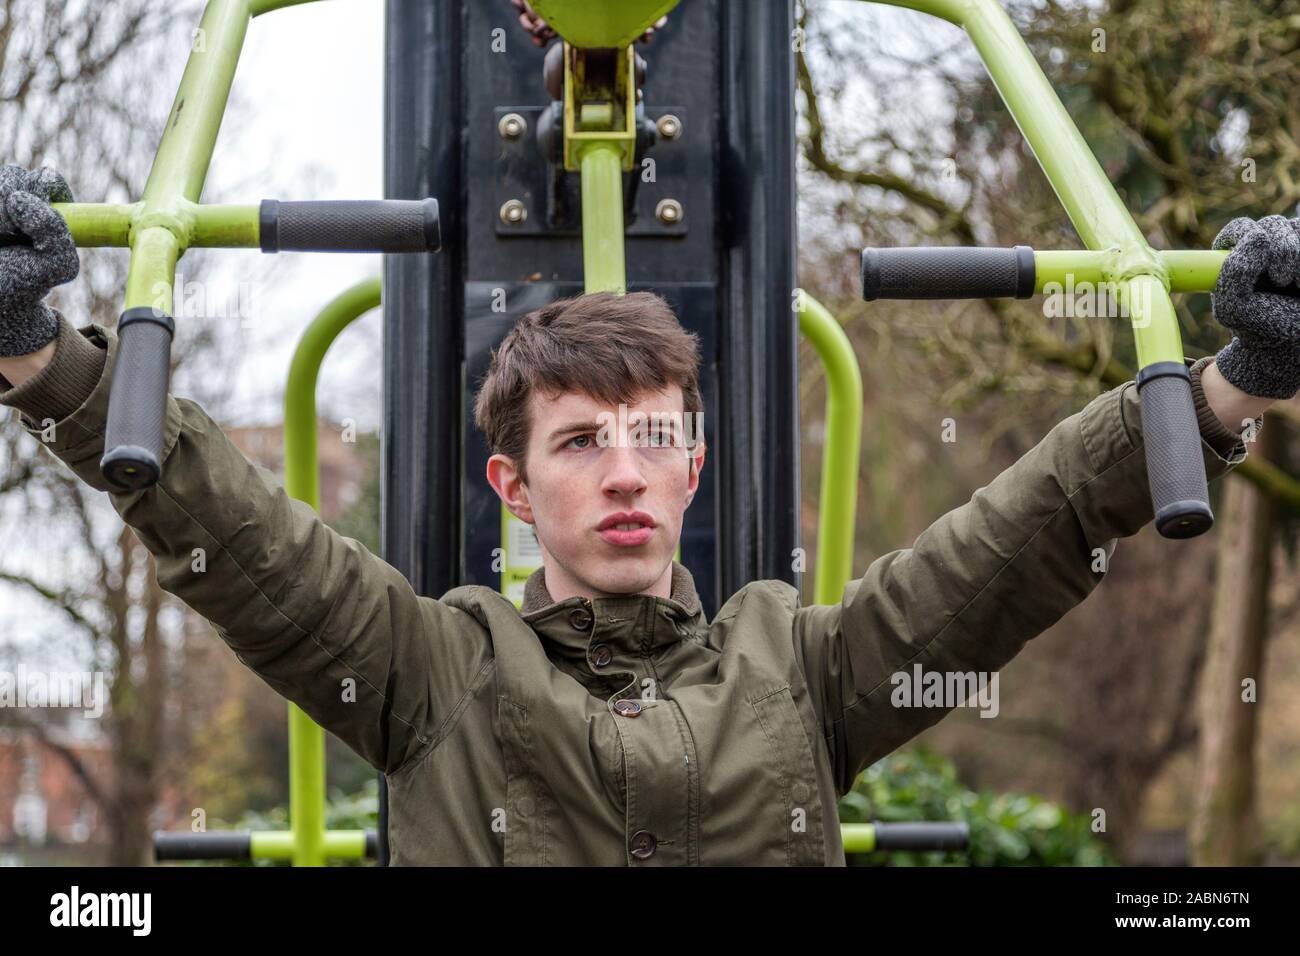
[0,316,1244,866]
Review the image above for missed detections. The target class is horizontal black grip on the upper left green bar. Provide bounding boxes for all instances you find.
[259,199,442,252]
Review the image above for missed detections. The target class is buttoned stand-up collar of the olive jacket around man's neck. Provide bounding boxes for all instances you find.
[519,561,705,657]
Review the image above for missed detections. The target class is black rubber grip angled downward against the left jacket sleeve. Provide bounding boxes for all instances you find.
[99,306,176,492]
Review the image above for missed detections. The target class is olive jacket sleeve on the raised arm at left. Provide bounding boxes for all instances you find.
[0,316,482,773]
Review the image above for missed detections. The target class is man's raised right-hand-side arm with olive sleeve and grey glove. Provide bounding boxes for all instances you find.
[794,216,1300,792]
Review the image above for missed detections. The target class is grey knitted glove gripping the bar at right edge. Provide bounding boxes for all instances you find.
[1213,216,1300,398]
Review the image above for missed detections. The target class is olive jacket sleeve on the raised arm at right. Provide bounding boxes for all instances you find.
[793,362,1245,793]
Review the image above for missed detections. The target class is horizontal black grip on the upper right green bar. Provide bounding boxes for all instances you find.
[862,246,1035,302]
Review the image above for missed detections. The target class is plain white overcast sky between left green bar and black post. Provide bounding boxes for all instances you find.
[197,0,385,428]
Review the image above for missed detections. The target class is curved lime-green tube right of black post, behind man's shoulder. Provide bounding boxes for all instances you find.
[800,290,862,604]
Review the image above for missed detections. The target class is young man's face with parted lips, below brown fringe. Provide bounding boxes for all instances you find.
[488,385,705,601]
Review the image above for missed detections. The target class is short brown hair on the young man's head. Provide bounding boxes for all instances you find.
[475,293,703,483]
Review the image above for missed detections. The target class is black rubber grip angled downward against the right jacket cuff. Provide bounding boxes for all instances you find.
[1138,362,1214,537]
